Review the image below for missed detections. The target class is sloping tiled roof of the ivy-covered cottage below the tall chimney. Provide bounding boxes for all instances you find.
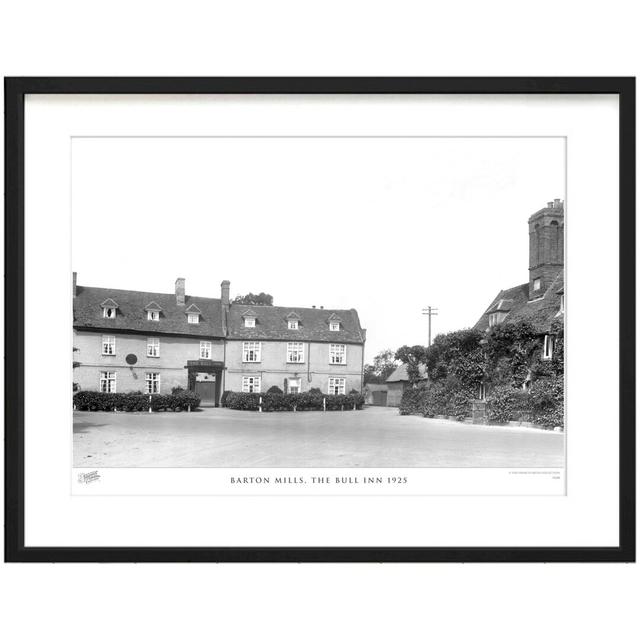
[474,271,564,333]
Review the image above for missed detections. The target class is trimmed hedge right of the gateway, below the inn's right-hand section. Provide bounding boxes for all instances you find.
[222,390,364,411]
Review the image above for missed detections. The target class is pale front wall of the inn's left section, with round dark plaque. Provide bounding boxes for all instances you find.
[73,331,224,393]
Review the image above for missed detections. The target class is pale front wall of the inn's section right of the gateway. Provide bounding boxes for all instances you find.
[224,340,364,393]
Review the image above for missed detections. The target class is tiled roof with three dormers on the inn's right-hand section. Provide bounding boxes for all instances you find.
[228,304,364,344]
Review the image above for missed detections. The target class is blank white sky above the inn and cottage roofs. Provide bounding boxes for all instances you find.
[71,137,565,362]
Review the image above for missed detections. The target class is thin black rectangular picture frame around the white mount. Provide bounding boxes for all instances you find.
[4,77,636,562]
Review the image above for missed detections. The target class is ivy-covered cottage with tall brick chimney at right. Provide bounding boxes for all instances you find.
[396,200,565,429]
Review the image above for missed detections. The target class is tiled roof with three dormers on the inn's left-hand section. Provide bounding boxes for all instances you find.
[73,286,224,337]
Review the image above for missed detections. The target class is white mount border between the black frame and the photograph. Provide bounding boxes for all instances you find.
[25,95,618,546]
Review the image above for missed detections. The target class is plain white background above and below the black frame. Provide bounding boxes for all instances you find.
[0,1,640,639]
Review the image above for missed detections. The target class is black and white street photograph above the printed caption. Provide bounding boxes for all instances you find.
[69,136,564,470]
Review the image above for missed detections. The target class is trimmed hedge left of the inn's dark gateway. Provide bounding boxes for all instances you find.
[73,391,200,411]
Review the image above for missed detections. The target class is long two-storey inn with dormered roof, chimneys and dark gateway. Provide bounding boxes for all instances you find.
[73,273,366,406]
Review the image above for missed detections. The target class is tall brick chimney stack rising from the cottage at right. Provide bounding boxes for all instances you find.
[529,198,564,300]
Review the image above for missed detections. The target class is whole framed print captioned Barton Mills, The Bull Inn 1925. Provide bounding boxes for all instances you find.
[5,78,635,562]
